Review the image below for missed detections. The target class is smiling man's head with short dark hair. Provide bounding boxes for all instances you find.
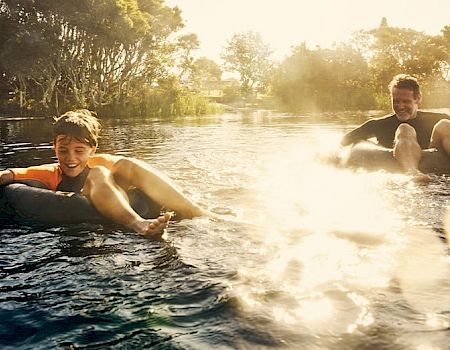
[389,74,422,121]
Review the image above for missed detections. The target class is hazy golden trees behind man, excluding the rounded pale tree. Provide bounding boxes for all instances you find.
[271,19,450,111]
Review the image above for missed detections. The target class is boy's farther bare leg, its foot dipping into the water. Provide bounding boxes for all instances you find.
[111,158,211,218]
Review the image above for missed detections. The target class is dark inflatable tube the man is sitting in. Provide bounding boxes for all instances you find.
[341,142,450,175]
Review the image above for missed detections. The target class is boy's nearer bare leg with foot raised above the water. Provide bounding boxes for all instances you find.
[83,167,170,235]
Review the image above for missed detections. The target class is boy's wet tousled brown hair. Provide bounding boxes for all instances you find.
[53,109,100,147]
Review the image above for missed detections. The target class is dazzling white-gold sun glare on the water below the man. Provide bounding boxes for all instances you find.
[227,131,449,340]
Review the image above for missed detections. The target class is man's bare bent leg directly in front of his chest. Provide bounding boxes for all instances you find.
[394,123,426,177]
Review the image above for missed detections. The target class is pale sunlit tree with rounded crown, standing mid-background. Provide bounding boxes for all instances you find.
[222,32,273,93]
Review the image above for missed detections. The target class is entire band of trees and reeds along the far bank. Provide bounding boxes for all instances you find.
[0,0,450,117]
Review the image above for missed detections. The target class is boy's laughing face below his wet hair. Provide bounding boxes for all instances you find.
[55,135,96,177]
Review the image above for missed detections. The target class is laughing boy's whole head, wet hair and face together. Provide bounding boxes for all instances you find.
[53,109,100,177]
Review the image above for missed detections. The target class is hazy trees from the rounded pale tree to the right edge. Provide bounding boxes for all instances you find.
[215,18,450,112]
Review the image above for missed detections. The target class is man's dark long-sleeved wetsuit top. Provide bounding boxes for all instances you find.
[343,111,450,149]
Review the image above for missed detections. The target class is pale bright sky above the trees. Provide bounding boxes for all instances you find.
[165,0,450,63]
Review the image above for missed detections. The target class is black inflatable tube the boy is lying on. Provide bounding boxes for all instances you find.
[0,184,161,224]
